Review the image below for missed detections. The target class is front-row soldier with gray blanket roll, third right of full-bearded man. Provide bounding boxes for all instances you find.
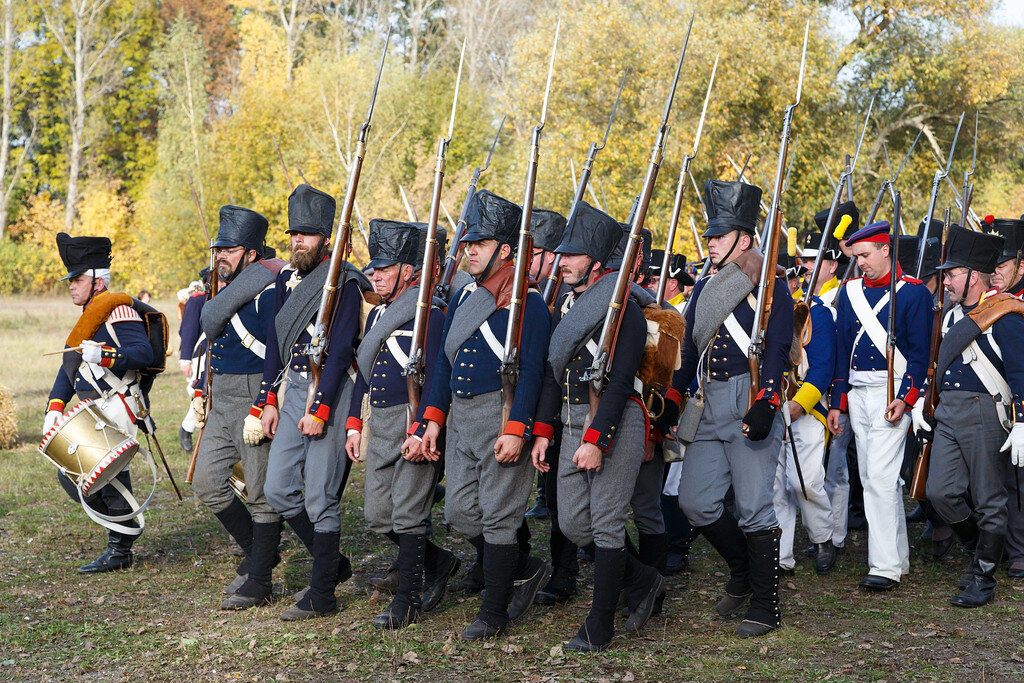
[531,202,665,652]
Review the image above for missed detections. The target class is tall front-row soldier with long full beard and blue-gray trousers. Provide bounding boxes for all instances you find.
[253,184,369,622]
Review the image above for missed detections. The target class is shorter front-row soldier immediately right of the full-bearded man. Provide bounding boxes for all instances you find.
[345,219,459,629]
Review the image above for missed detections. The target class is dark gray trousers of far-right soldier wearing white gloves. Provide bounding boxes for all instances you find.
[927,391,1016,535]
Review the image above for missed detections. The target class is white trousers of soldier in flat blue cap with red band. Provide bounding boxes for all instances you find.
[849,384,910,581]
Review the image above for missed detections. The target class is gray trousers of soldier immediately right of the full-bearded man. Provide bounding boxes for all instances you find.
[362,403,438,533]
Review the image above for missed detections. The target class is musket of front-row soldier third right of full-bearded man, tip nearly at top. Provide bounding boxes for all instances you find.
[584,13,694,421]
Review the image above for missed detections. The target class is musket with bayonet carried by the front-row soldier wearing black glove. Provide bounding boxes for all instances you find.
[746,19,811,407]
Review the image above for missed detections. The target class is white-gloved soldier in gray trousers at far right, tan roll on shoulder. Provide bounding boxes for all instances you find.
[913,225,1024,607]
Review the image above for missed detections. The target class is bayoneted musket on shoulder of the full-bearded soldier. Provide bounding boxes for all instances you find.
[304,27,391,412]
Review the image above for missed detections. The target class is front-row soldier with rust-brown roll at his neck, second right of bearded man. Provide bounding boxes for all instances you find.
[406,189,551,640]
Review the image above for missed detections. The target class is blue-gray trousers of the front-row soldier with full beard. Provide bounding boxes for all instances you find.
[265,371,352,532]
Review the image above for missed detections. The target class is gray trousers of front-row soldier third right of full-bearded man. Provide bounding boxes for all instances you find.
[558,400,647,550]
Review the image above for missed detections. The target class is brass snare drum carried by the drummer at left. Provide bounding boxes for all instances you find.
[39,399,139,496]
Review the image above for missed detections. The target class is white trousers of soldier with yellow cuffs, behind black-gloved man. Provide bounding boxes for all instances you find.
[772,413,835,569]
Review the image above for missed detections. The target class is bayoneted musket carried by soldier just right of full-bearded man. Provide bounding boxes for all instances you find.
[398,38,468,428]
